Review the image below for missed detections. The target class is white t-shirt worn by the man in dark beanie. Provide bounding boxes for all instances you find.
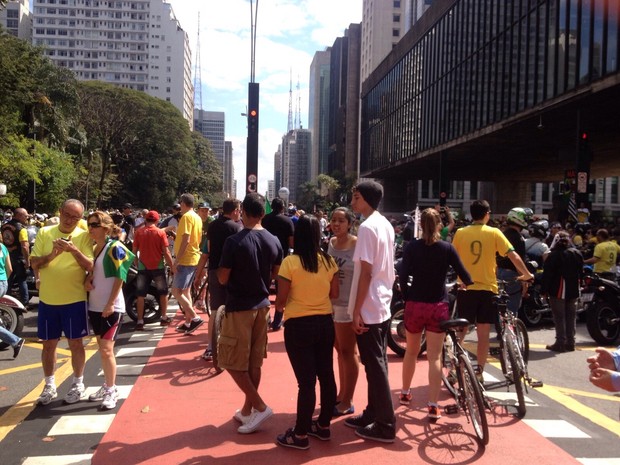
[349,211,395,324]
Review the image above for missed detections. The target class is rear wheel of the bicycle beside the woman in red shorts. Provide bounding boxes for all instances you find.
[458,354,489,445]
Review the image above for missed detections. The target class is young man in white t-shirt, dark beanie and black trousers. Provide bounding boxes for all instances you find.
[345,181,396,443]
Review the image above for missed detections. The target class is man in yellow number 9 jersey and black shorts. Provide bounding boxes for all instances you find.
[452,200,534,381]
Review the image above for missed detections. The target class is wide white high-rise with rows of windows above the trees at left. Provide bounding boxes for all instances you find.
[32,0,193,125]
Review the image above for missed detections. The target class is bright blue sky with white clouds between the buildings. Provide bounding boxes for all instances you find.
[167,0,362,197]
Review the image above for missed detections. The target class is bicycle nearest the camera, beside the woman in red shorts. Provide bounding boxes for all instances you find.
[440,318,489,446]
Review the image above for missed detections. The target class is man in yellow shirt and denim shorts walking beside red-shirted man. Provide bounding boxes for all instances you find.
[172,194,204,334]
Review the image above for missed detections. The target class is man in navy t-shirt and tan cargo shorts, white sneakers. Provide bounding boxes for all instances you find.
[217,193,282,434]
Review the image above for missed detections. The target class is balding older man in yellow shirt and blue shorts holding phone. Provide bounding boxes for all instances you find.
[30,199,93,405]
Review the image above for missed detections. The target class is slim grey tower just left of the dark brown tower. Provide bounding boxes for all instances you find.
[308,47,331,179]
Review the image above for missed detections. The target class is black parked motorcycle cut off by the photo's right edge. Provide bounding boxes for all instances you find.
[581,273,620,346]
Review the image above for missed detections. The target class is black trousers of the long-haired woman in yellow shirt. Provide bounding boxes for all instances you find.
[284,314,336,436]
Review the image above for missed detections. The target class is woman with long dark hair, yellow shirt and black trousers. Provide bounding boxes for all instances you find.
[276,215,339,449]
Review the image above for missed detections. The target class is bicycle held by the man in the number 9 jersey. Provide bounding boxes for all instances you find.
[485,281,542,418]
